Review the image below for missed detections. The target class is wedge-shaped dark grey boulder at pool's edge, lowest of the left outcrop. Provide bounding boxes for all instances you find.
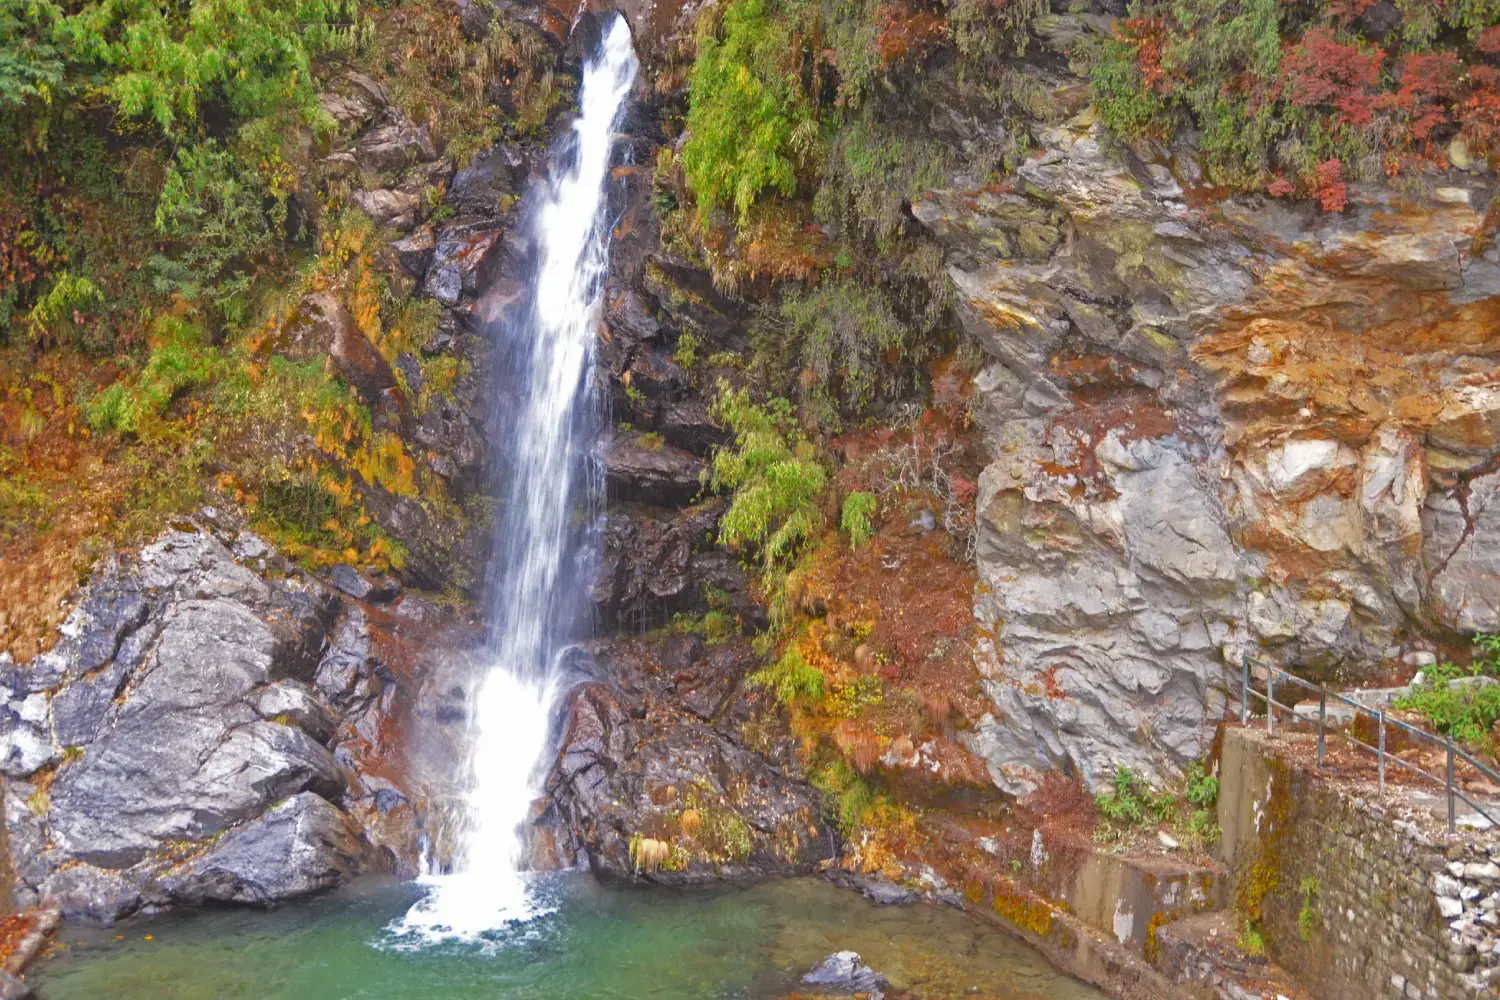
[161,792,365,906]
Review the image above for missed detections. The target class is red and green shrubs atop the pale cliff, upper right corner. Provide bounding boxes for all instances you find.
[1094,0,1500,200]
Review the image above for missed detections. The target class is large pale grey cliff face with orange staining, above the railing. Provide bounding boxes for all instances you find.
[912,111,1500,792]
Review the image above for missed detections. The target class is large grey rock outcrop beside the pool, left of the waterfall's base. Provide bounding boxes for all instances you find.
[0,529,456,922]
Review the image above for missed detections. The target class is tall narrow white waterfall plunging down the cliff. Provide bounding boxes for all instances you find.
[392,15,638,940]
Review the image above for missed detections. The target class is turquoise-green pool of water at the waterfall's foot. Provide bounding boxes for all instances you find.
[29,876,1103,1000]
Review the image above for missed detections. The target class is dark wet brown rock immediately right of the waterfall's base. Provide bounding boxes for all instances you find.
[533,636,836,885]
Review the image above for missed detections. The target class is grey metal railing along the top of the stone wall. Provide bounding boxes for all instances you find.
[1239,657,1500,834]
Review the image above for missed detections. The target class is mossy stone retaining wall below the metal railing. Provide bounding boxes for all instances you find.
[1218,729,1500,1000]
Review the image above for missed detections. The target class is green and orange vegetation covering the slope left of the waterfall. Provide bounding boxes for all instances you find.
[0,0,566,657]
